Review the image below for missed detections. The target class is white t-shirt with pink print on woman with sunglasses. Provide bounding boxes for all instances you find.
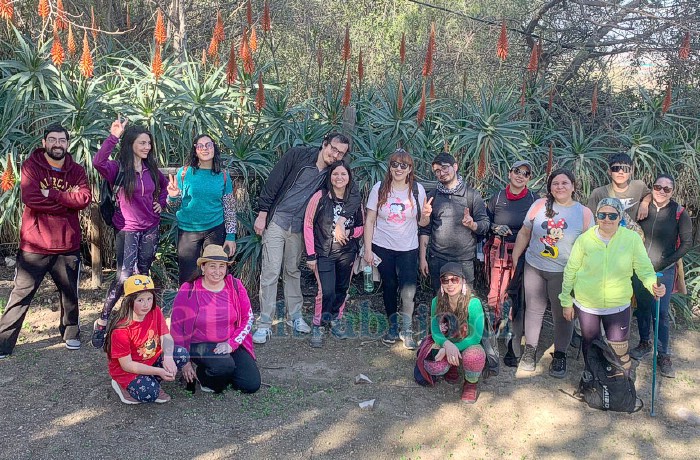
[367,182,425,251]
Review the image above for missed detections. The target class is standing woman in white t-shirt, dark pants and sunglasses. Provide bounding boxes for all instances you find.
[364,149,429,350]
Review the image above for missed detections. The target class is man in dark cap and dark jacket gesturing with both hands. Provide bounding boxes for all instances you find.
[418,152,489,292]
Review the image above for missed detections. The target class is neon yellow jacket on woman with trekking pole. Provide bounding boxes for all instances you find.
[559,225,656,310]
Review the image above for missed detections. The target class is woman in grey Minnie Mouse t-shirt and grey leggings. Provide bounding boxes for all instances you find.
[513,169,593,378]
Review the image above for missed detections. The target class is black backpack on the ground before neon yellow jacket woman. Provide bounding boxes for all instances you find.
[574,338,643,414]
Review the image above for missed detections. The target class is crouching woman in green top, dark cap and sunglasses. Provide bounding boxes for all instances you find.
[413,262,486,404]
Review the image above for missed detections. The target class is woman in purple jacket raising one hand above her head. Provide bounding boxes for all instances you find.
[92,119,168,348]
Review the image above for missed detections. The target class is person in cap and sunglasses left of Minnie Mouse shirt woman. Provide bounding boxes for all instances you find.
[484,160,537,366]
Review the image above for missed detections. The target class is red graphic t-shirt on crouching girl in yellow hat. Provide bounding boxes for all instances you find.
[109,306,170,388]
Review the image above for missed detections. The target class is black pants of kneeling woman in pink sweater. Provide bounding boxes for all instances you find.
[190,342,260,393]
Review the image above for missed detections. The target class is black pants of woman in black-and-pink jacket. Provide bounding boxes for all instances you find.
[314,251,357,324]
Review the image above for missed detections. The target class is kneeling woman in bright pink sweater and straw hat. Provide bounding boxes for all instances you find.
[170,244,260,393]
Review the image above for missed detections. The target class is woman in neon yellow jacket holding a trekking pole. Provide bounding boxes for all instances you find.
[559,198,666,378]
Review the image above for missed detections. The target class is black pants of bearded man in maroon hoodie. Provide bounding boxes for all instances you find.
[0,250,80,354]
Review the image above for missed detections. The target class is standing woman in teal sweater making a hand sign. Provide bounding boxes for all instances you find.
[168,135,236,284]
